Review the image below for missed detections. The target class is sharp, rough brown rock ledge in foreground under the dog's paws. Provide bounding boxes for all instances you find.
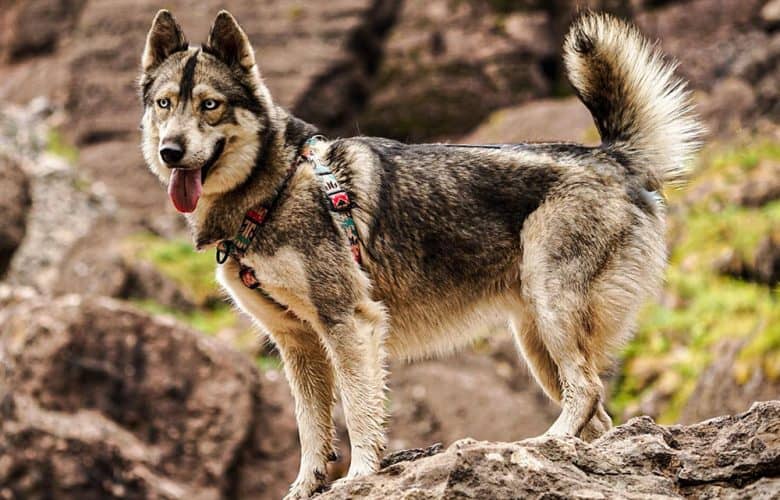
[318,401,780,500]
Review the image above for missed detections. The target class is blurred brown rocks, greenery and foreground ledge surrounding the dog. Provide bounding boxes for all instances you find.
[0,0,780,499]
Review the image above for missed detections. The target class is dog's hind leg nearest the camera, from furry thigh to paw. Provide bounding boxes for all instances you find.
[520,195,665,438]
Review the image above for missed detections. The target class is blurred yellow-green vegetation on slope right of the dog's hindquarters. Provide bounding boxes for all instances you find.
[611,141,780,422]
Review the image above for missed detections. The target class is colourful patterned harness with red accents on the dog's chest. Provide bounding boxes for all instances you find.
[216,135,361,292]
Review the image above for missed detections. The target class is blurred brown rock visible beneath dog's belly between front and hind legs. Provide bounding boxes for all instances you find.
[389,332,558,450]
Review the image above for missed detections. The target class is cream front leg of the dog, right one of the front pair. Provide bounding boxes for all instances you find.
[316,299,386,478]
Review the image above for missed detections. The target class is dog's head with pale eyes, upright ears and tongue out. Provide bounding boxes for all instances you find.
[140,10,273,212]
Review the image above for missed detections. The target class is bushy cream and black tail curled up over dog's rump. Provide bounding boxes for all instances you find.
[564,12,704,187]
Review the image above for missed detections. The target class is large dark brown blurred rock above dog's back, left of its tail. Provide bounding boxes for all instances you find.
[354,0,560,141]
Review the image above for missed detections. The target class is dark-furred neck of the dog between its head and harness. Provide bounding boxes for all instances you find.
[187,108,317,249]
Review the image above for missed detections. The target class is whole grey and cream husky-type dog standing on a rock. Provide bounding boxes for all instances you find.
[139,10,702,498]
